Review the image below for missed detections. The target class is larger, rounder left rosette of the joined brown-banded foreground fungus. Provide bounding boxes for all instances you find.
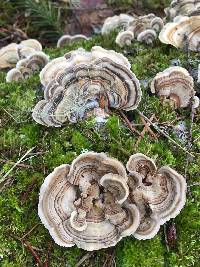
[38,152,140,251]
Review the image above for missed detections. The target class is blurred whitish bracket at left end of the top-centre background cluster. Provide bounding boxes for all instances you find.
[101,14,134,35]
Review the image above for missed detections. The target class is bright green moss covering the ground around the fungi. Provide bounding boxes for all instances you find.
[0,34,200,267]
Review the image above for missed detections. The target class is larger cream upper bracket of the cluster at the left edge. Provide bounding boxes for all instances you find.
[0,39,42,69]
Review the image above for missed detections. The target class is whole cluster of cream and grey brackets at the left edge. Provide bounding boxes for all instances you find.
[0,39,49,82]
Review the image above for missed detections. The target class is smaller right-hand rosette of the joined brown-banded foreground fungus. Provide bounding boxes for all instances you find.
[127,153,187,239]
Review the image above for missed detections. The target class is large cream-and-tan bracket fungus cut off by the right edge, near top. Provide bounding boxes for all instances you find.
[159,16,200,52]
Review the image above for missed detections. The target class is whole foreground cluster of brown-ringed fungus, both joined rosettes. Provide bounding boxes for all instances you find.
[38,152,186,251]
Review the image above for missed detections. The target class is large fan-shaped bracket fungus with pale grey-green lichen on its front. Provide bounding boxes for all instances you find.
[33,46,141,127]
